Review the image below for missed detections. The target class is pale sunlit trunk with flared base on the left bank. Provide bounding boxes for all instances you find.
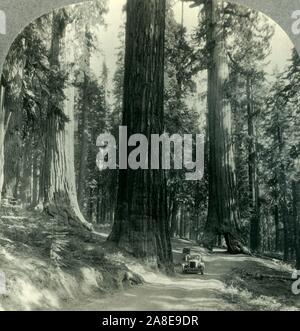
[43,11,92,230]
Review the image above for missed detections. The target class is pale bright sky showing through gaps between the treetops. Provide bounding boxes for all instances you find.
[92,0,293,95]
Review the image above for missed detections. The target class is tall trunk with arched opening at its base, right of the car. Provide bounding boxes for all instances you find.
[202,0,245,254]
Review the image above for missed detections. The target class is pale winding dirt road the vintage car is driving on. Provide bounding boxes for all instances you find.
[73,240,299,311]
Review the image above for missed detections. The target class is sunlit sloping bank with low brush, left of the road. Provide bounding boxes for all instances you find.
[0,207,142,311]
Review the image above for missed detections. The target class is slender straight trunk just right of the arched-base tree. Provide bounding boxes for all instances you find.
[246,75,261,251]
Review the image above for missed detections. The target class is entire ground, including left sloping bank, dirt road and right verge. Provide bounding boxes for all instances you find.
[0,208,300,311]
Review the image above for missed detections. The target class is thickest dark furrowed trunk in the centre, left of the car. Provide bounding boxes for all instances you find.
[109,0,172,270]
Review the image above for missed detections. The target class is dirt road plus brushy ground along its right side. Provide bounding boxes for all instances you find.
[70,239,300,311]
